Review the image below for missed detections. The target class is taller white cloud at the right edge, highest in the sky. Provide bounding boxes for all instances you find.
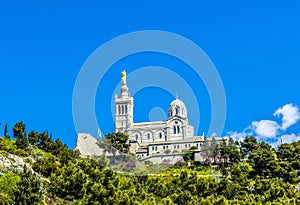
[273,103,300,131]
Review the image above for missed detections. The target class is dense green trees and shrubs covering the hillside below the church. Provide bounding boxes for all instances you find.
[0,122,300,205]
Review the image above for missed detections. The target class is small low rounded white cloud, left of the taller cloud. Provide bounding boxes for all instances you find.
[252,120,280,138]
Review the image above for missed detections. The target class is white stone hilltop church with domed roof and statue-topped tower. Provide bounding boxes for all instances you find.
[114,71,224,162]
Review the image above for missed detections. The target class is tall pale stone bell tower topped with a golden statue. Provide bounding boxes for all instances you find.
[115,70,133,134]
